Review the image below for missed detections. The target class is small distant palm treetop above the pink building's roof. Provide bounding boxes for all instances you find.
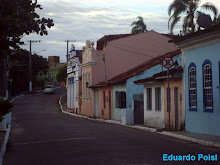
[131,16,147,34]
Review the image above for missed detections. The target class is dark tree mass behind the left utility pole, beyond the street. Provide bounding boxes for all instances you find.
[9,49,49,94]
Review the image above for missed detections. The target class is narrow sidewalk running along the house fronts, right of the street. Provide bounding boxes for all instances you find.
[59,95,220,148]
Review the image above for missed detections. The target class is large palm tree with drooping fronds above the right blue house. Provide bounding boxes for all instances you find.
[168,0,218,33]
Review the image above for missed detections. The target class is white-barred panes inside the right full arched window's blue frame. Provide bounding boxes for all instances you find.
[203,63,212,109]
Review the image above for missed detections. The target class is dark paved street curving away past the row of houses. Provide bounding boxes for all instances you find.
[3,89,220,165]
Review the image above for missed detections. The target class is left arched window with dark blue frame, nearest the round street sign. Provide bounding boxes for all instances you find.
[188,63,197,111]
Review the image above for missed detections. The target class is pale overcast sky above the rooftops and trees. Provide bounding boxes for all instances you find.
[20,0,220,62]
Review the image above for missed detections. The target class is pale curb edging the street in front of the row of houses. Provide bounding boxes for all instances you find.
[59,94,220,148]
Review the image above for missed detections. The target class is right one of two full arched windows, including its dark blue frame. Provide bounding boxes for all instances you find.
[202,60,213,112]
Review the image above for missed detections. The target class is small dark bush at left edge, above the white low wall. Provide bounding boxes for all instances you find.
[0,99,13,121]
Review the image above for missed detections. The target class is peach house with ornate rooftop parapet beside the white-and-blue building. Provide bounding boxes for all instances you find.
[80,41,105,117]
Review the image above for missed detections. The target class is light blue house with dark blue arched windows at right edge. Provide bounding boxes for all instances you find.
[174,27,220,136]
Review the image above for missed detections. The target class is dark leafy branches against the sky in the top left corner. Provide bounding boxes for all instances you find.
[0,0,54,57]
